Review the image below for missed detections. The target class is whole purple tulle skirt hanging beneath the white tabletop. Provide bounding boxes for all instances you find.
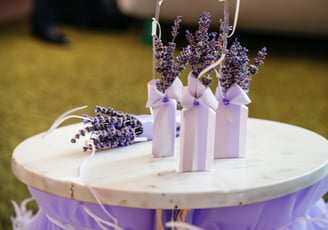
[29,176,328,230]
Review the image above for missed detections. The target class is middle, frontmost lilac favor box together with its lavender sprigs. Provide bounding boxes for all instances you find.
[178,12,224,172]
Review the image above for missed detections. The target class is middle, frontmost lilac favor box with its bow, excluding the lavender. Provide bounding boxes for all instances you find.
[178,74,218,172]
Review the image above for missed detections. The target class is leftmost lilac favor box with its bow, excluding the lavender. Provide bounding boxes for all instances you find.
[146,78,182,157]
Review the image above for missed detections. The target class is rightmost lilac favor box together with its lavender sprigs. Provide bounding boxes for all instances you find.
[214,39,267,158]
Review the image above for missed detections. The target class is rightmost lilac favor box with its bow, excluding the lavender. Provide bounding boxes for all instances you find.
[214,85,250,159]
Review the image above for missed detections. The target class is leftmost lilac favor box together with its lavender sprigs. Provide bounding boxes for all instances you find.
[146,16,187,157]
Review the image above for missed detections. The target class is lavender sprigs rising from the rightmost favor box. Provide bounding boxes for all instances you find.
[219,38,267,93]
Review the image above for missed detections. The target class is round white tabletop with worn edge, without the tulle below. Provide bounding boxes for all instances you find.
[12,119,328,209]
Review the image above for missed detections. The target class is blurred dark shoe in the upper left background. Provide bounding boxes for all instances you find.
[32,28,70,45]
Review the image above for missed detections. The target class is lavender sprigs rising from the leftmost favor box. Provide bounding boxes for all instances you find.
[154,16,188,93]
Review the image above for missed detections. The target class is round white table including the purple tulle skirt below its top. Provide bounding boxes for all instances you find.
[12,119,328,229]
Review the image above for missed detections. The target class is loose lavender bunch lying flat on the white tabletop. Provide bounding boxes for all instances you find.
[71,106,143,151]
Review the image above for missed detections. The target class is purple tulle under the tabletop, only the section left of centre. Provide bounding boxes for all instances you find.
[29,187,155,230]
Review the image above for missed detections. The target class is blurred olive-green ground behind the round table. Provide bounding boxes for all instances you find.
[0,22,328,229]
